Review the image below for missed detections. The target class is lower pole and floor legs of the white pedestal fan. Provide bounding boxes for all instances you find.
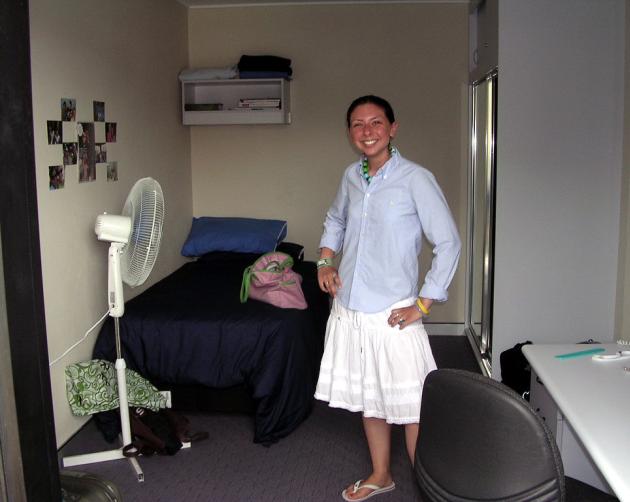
[63,317,144,483]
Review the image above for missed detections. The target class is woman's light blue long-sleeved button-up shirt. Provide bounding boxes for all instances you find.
[319,150,461,312]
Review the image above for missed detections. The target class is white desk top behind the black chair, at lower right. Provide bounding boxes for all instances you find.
[523,343,630,502]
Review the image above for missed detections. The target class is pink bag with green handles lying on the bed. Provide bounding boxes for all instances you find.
[241,251,308,310]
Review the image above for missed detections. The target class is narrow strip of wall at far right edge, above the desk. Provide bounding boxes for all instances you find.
[615,2,630,341]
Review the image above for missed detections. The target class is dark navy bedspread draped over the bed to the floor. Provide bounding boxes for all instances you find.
[93,253,328,444]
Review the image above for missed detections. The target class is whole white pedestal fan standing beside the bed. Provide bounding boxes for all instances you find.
[63,178,164,481]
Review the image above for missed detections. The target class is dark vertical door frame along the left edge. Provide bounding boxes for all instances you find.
[0,0,61,501]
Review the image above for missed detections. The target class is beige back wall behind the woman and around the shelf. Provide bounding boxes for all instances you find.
[189,4,468,322]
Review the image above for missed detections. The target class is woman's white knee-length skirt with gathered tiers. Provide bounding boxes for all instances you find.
[315,298,436,424]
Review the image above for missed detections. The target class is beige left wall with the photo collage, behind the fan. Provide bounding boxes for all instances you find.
[30,0,192,444]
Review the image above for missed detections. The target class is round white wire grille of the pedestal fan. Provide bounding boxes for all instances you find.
[121,178,164,287]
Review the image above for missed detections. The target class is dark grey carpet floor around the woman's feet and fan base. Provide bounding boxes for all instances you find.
[59,336,478,502]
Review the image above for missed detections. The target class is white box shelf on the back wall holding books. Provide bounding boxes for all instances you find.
[181,78,291,125]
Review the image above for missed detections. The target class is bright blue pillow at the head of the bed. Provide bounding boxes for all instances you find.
[182,216,287,257]
